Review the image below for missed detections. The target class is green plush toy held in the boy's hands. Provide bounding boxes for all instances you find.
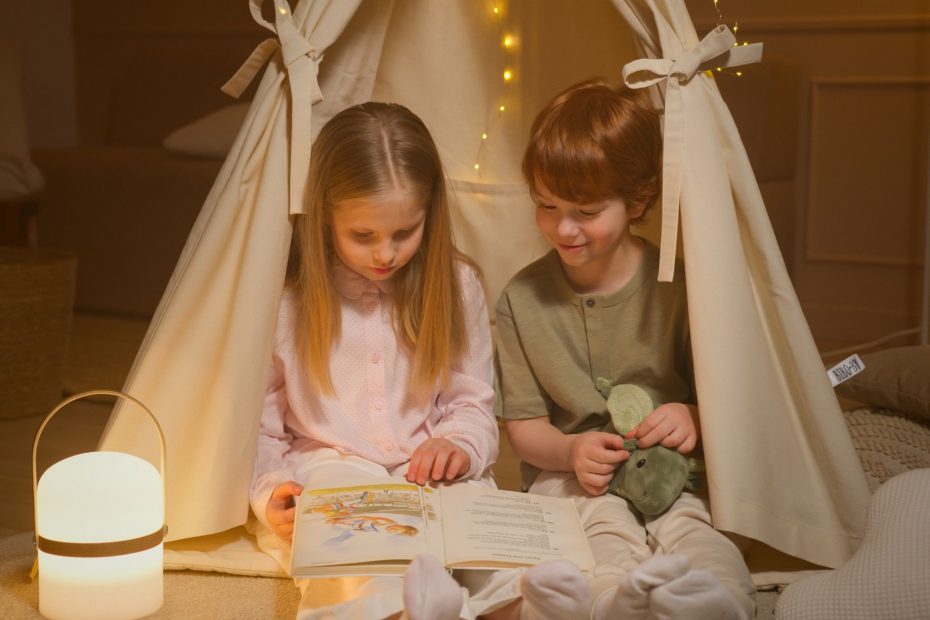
[595,378,704,516]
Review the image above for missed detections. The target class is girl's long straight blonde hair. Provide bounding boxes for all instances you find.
[290,102,468,395]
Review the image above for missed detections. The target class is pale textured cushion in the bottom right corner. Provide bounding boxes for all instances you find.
[775,469,930,620]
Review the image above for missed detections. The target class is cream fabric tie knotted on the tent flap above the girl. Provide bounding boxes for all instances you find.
[221,0,323,214]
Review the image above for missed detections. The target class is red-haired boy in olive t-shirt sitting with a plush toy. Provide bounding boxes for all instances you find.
[496,80,754,620]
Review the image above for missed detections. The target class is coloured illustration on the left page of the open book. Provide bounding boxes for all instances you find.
[303,484,437,548]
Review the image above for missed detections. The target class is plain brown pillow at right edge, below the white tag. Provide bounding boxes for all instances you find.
[836,345,930,419]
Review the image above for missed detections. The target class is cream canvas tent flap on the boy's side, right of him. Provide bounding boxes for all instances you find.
[613,0,869,567]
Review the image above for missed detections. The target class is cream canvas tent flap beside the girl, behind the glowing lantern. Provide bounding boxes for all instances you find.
[100,0,392,540]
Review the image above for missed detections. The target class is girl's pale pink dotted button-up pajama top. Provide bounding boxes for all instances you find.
[245,262,498,526]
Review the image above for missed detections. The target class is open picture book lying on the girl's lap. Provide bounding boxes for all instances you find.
[291,478,594,577]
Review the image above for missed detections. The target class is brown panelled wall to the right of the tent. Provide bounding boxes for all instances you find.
[688,0,930,348]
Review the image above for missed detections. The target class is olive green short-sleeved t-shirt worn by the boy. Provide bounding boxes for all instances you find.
[496,241,697,486]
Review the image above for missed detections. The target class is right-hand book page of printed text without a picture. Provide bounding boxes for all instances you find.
[441,484,594,570]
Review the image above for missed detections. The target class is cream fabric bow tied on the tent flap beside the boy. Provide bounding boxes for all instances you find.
[623,25,762,282]
